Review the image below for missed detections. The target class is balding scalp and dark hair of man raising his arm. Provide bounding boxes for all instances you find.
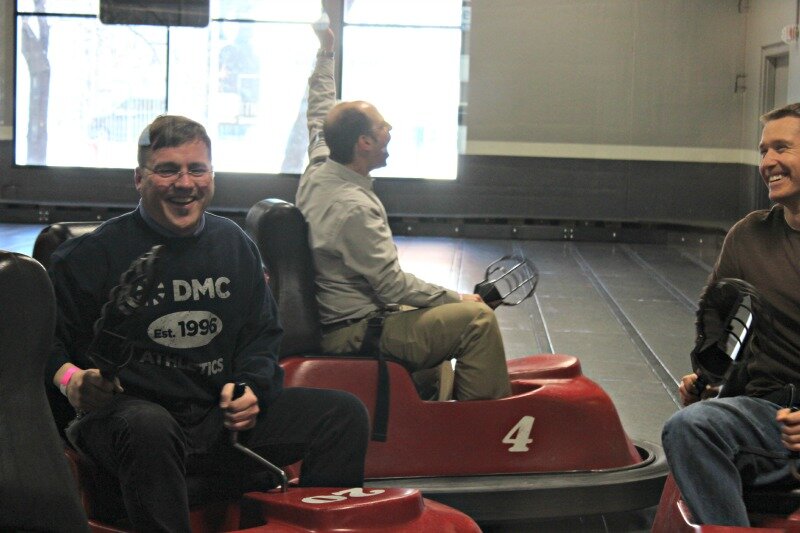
[323,100,377,165]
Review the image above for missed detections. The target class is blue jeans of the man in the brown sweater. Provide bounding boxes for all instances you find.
[662,396,796,526]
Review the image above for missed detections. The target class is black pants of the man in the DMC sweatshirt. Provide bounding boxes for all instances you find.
[68,388,369,532]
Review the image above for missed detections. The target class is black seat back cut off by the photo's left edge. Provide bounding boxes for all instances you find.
[0,250,88,531]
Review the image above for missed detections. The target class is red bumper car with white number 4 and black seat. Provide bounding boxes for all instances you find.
[246,200,667,523]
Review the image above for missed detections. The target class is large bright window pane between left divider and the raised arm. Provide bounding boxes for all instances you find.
[169,21,319,173]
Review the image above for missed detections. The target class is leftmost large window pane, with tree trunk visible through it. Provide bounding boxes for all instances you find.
[14,16,167,168]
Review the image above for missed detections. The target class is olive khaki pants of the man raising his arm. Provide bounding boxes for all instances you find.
[322,302,511,400]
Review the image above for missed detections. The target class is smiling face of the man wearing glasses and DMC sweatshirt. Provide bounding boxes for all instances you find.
[134,140,214,236]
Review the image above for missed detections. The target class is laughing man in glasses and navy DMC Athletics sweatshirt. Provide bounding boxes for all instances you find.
[46,115,368,533]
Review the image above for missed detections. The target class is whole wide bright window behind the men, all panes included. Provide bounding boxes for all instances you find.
[14,0,462,178]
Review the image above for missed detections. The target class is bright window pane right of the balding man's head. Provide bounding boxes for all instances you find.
[342,26,461,179]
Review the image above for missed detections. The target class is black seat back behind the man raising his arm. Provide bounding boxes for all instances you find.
[245,199,321,357]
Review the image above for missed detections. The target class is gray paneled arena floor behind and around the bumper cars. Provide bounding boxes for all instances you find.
[0,224,721,531]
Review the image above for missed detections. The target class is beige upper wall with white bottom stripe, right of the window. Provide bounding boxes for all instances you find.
[467,0,761,162]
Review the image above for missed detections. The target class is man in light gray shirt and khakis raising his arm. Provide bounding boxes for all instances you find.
[297,25,511,400]
